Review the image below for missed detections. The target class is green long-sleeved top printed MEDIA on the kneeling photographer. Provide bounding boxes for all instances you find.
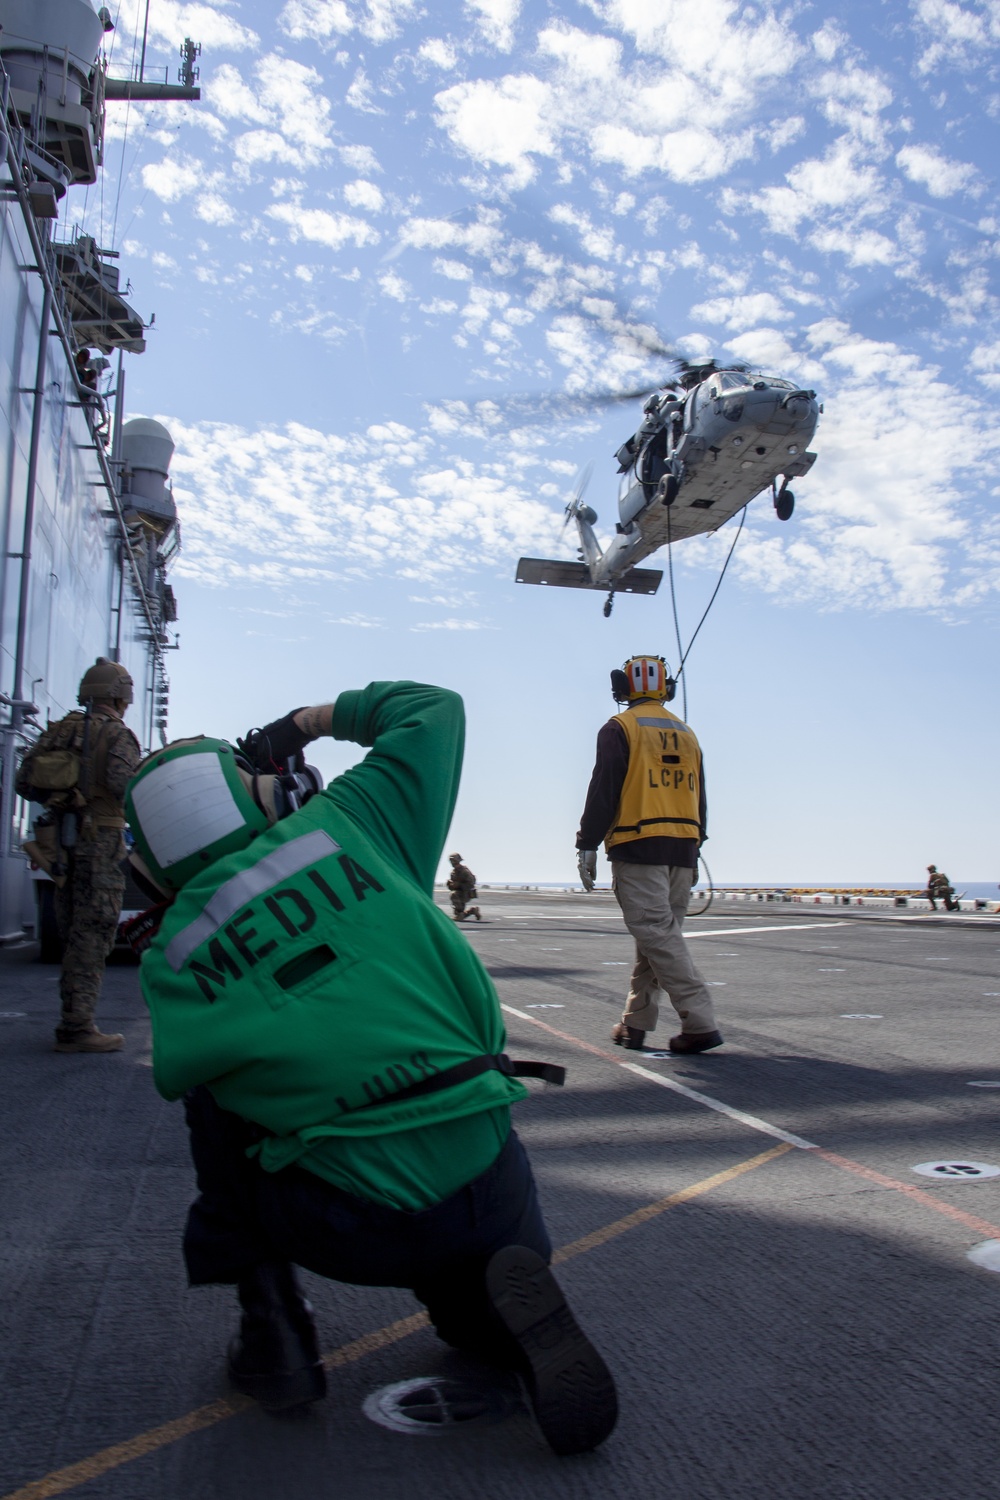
[141,683,526,1211]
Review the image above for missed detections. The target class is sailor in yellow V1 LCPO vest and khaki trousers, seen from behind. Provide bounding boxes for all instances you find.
[576,656,723,1053]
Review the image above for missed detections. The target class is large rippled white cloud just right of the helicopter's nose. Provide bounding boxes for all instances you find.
[685,320,1000,614]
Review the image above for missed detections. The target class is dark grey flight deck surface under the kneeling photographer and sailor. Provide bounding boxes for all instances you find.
[0,893,1000,1500]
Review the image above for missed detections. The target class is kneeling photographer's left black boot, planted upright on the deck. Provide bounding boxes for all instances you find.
[229,1262,327,1412]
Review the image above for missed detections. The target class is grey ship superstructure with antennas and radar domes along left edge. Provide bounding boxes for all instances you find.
[0,0,198,941]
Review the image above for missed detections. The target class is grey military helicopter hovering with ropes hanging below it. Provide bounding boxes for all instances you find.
[516,357,823,617]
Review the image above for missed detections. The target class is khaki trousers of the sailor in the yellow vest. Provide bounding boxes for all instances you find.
[612,861,715,1032]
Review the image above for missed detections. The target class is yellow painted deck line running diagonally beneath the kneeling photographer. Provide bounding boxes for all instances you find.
[0,1146,793,1500]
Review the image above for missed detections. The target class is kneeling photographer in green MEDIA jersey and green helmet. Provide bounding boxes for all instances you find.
[127,683,616,1454]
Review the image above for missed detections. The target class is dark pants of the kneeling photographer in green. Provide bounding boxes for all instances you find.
[184,1088,552,1355]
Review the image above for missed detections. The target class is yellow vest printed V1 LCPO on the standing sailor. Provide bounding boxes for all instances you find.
[604,702,702,851]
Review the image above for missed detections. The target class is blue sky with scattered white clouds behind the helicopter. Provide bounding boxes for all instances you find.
[63,0,1000,884]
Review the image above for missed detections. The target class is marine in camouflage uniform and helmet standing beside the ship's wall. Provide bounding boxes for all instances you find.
[24,657,141,1052]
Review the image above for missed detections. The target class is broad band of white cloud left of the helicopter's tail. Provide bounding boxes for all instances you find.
[163,419,558,591]
